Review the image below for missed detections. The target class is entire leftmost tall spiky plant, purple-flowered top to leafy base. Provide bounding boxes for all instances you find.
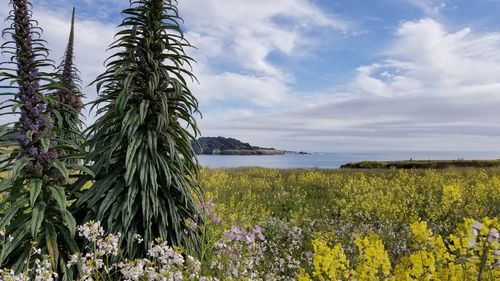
[0,0,78,280]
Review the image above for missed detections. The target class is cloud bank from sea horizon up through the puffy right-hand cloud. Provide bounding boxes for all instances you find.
[202,18,500,151]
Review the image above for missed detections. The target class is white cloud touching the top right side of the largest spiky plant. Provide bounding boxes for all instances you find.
[179,0,350,108]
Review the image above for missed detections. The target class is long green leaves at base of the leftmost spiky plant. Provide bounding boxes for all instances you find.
[0,147,78,280]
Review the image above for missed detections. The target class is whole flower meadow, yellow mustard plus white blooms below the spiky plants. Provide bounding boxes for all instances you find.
[0,168,500,281]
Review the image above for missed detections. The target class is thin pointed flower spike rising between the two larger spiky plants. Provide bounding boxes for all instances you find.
[55,8,83,143]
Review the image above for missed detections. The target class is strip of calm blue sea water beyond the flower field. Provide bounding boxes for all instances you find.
[198,151,500,168]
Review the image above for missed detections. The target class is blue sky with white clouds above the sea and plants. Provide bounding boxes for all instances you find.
[0,0,500,152]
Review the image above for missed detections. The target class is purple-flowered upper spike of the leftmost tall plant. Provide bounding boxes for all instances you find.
[11,1,57,175]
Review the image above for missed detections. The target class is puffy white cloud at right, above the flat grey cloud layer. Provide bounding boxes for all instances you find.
[353,18,500,96]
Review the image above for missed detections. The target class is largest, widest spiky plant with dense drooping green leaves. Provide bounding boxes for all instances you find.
[79,0,199,258]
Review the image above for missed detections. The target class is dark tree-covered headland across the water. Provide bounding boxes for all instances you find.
[193,137,285,155]
